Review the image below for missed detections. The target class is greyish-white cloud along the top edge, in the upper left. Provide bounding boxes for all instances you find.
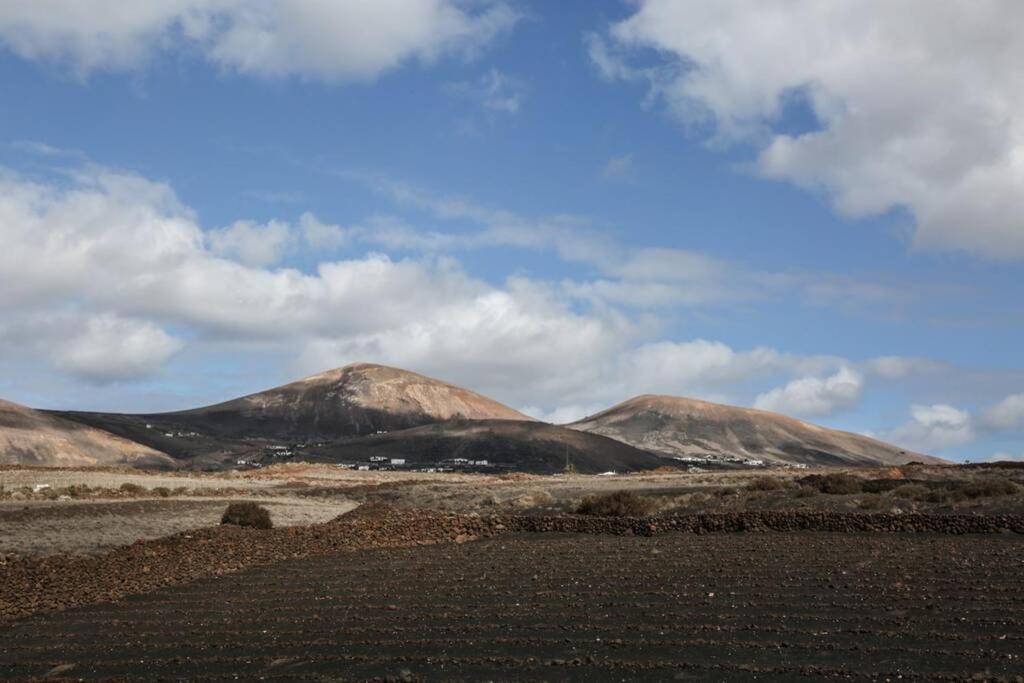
[0,0,519,81]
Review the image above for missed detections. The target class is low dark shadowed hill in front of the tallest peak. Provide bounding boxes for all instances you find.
[304,420,671,474]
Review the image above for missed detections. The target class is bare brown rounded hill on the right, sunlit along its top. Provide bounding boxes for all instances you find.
[568,395,942,465]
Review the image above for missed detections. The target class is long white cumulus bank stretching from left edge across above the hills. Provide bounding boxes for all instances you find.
[0,160,929,421]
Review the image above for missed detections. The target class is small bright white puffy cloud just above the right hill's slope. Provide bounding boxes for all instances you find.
[754,367,864,417]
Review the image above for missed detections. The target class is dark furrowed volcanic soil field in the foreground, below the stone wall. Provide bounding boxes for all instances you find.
[0,531,1024,681]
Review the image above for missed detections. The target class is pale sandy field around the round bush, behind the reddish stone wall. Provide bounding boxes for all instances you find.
[0,497,356,557]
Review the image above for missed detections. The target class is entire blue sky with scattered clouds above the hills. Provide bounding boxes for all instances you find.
[0,0,1024,461]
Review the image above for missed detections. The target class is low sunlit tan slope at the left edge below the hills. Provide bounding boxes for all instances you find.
[0,400,172,467]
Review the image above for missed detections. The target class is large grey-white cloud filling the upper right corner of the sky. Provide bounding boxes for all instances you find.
[590,0,1024,260]
